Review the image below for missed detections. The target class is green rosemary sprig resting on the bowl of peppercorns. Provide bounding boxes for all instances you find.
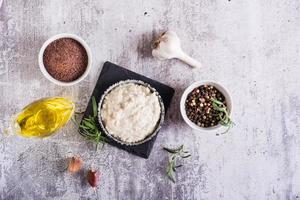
[211,99,234,134]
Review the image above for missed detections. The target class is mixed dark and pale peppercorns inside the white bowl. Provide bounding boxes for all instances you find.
[185,85,226,128]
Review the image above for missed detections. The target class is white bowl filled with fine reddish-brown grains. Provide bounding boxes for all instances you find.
[38,33,92,86]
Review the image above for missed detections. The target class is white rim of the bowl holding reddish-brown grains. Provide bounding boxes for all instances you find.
[38,33,92,86]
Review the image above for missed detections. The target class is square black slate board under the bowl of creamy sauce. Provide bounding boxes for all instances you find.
[83,62,174,158]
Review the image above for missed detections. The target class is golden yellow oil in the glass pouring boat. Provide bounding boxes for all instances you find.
[15,97,75,137]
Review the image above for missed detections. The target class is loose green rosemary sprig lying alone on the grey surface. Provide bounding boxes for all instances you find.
[163,145,191,183]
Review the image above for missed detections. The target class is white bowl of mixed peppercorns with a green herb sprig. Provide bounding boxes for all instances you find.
[180,81,233,131]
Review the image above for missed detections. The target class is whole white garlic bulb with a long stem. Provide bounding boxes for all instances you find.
[152,31,201,68]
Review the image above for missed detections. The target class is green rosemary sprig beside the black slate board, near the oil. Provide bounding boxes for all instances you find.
[72,96,108,149]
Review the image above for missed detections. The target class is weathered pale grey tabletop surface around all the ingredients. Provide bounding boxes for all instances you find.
[0,0,300,200]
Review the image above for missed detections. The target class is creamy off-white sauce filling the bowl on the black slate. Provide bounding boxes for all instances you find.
[101,83,161,143]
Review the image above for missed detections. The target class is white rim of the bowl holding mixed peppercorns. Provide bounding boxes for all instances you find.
[180,81,232,131]
